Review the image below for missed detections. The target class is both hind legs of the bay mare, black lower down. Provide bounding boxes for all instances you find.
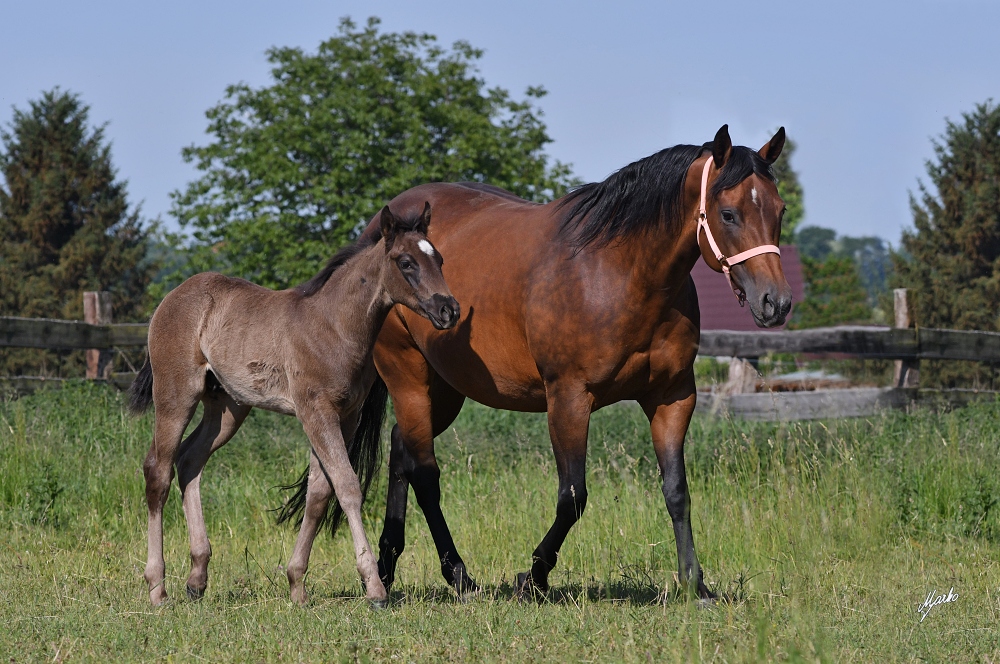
[379,364,468,595]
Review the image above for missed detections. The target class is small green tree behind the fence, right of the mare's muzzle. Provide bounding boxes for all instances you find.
[789,255,872,329]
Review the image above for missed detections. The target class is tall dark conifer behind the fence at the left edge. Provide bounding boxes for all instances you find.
[0,88,155,373]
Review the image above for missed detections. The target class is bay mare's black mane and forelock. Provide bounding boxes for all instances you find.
[558,142,774,248]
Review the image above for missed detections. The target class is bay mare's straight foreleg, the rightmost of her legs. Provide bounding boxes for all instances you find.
[639,373,715,599]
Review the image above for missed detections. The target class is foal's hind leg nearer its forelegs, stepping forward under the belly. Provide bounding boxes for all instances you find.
[177,388,250,599]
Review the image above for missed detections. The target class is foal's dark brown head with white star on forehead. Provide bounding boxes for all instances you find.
[380,203,460,330]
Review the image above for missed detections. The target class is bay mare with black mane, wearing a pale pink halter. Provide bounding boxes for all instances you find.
[284,126,791,599]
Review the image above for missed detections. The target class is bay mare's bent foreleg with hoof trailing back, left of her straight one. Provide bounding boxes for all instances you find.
[517,383,593,597]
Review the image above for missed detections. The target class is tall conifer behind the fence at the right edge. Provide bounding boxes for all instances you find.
[893,101,1000,385]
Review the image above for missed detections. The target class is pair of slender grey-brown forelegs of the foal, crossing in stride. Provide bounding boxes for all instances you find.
[288,413,389,606]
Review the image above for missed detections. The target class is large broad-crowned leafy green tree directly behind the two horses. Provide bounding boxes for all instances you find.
[173,18,576,287]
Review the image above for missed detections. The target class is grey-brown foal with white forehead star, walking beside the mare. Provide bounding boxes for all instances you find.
[130,202,459,606]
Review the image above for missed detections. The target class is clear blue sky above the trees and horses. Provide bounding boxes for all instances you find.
[0,0,1000,244]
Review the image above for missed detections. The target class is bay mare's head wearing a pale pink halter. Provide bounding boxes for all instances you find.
[695,125,792,327]
